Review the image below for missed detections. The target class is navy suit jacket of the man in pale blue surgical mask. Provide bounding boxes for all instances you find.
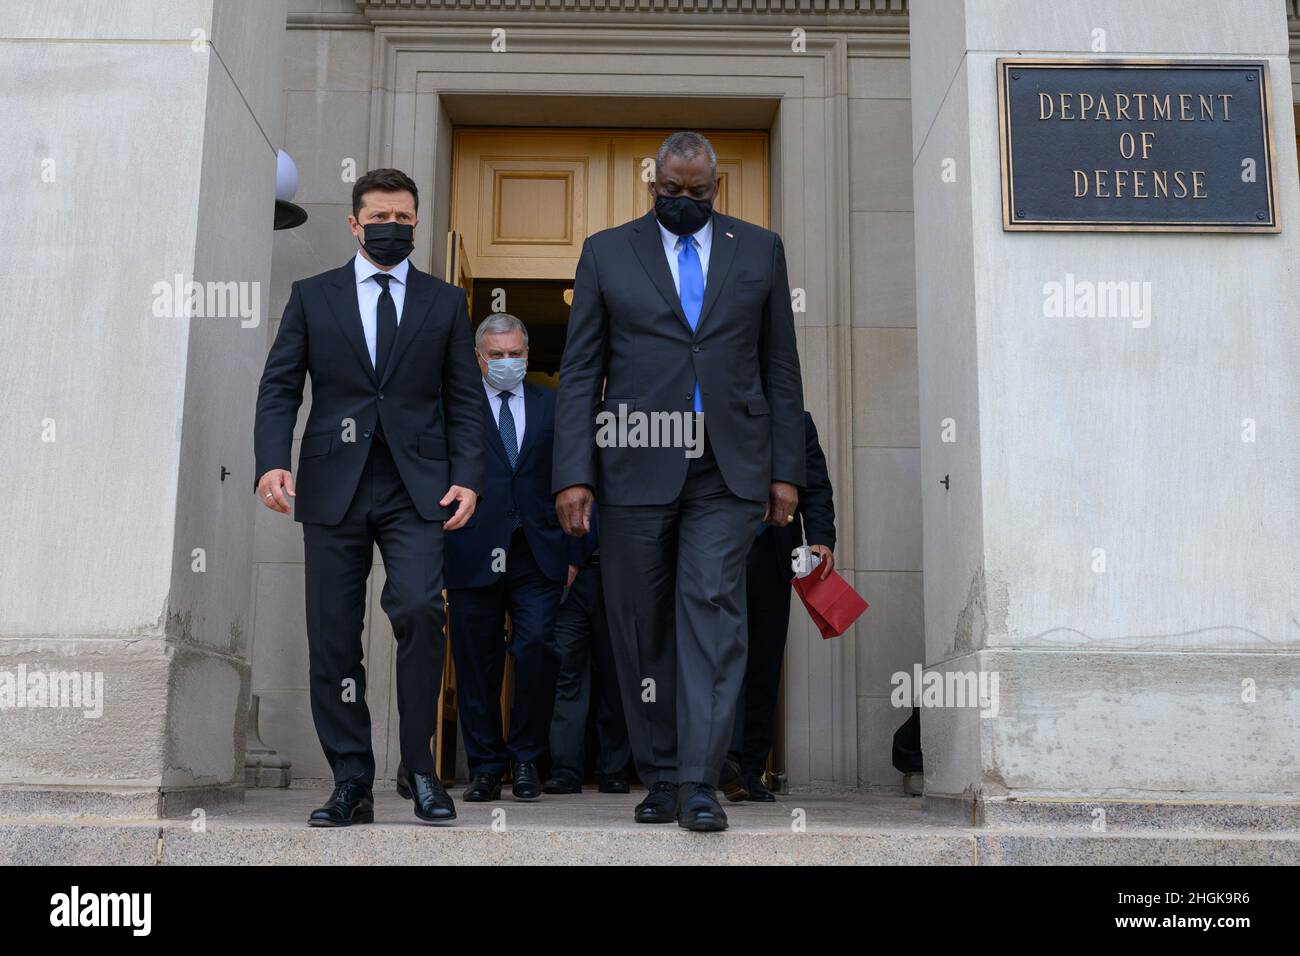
[443,382,568,588]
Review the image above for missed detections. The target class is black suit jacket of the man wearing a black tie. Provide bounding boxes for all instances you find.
[254,260,484,524]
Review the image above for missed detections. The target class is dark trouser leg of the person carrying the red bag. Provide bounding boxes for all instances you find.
[731,531,794,774]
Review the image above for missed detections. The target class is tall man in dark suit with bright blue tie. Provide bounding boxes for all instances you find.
[553,133,803,830]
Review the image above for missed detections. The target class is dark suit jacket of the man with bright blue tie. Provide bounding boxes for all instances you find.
[551,212,803,505]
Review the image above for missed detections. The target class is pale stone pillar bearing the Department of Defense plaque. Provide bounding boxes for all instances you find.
[910,0,1300,829]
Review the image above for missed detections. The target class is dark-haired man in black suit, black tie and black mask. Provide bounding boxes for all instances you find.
[254,169,484,826]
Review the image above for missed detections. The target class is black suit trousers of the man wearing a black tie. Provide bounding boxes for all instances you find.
[303,442,446,783]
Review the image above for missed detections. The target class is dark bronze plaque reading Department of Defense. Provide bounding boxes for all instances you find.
[997,57,1282,233]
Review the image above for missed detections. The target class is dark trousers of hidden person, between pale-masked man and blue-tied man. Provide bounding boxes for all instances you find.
[551,562,632,778]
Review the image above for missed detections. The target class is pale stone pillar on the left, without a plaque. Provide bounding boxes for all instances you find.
[0,0,285,816]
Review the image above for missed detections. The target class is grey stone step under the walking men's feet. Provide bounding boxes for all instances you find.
[0,790,1300,866]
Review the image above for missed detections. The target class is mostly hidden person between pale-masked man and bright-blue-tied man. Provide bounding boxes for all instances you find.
[543,509,632,793]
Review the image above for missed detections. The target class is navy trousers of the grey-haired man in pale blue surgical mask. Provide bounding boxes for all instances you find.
[447,528,564,774]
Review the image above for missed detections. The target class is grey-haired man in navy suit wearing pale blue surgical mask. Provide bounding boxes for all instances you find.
[447,313,568,803]
